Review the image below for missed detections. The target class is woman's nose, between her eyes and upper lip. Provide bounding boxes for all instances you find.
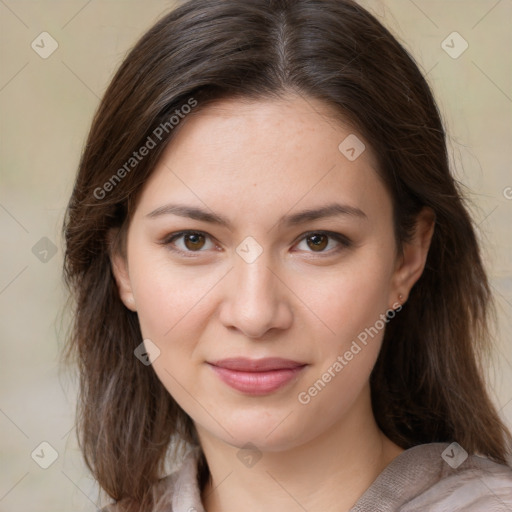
[220,251,293,339]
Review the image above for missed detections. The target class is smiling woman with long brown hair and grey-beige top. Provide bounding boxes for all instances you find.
[65,0,512,512]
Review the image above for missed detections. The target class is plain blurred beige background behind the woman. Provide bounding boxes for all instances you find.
[0,0,512,512]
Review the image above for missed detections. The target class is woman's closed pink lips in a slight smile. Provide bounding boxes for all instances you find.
[208,357,306,395]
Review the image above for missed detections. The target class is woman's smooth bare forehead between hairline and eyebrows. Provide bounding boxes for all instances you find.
[134,96,390,230]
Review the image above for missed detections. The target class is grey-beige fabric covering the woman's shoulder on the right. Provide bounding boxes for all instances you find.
[351,443,512,512]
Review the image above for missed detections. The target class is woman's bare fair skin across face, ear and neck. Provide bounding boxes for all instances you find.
[112,95,434,512]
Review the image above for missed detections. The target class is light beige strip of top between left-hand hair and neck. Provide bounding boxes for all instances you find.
[100,450,203,512]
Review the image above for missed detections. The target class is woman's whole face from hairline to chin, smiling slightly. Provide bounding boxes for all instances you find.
[114,96,424,450]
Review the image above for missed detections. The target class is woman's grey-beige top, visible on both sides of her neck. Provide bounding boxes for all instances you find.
[103,443,512,512]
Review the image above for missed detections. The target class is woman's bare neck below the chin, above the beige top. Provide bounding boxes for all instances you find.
[198,392,403,512]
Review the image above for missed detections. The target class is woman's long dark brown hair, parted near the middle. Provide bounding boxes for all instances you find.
[64,0,510,509]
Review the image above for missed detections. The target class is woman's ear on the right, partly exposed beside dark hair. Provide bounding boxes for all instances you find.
[389,207,436,305]
